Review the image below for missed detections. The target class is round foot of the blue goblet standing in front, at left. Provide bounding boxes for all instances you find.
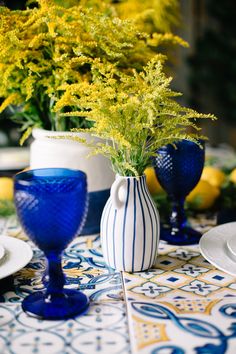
[22,289,89,320]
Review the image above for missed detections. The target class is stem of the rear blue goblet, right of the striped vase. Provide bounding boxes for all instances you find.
[170,198,187,233]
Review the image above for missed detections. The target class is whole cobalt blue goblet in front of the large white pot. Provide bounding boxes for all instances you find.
[14,168,89,320]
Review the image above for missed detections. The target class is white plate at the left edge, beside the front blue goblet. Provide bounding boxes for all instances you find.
[0,235,33,279]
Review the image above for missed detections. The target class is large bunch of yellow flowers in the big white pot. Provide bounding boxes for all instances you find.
[0,0,187,140]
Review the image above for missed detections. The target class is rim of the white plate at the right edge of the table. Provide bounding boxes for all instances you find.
[199,221,236,277]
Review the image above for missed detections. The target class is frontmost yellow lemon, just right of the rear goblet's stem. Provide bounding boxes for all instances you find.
[186,180,220,210]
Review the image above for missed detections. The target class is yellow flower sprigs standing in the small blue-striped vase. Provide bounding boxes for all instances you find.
[55,56,215,177]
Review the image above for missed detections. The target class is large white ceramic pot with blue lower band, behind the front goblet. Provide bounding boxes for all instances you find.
[30,129,115,235]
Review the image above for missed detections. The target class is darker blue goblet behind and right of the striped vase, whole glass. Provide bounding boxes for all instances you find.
[154,140,205,245]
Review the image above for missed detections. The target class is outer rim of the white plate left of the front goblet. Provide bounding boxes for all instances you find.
[0,235,33,280]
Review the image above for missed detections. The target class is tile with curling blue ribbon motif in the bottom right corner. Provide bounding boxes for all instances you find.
[128,299,236,354]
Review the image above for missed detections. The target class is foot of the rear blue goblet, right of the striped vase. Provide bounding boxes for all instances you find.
[160,225,202,246]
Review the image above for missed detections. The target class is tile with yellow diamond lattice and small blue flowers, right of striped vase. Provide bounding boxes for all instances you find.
[123,243,236,302]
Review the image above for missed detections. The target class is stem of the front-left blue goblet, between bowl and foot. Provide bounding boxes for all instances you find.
[46,252,65,298]
